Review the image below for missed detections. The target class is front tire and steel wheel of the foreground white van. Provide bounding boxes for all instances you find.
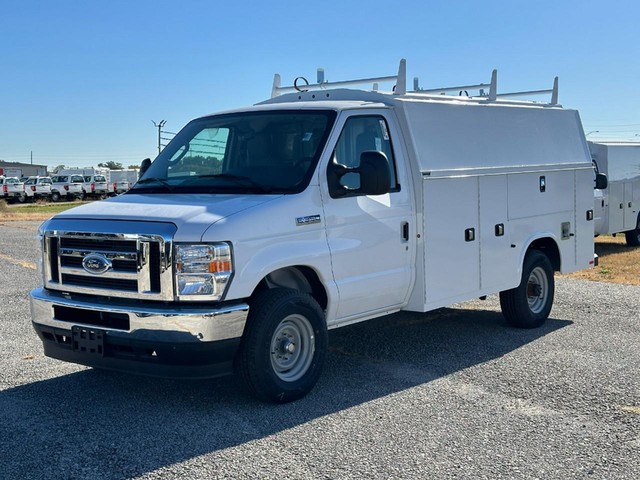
[235,288,328,403]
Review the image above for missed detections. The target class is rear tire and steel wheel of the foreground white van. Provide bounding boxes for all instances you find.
[500,250,555,328]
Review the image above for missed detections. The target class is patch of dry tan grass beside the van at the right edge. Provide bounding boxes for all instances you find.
[569,234,640,285]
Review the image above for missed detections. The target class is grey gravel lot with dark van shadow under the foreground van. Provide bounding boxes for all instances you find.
[0,220,640,479]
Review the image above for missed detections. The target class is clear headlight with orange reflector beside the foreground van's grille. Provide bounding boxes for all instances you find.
[174,243,233,300]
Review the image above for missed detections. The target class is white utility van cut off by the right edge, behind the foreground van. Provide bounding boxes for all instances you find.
[588,142,640,247]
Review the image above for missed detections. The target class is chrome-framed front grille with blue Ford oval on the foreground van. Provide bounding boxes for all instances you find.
[43,219,175,300]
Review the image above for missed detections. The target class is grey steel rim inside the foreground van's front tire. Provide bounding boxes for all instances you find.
[270,314,315,382]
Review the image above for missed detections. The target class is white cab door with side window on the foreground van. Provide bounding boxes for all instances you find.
[323,110,416,323]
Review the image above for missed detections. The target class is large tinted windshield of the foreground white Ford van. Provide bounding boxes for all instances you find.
[130,110,335,194]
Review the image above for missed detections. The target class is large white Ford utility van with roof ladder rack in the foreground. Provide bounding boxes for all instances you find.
[31,60,594,402]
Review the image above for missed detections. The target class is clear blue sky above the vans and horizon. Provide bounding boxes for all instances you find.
[0,0,640,171]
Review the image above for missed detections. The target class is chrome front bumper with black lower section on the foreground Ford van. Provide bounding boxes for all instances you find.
[31,288,249,379]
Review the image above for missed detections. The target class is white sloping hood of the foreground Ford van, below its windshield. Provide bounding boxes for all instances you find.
[55,194,282,241]
